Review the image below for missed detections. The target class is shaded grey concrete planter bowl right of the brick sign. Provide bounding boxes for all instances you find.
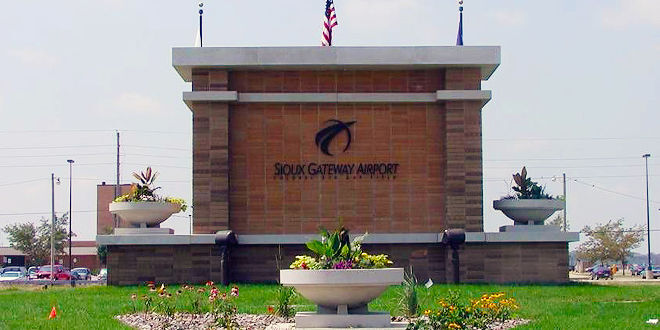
[493,199,566,225]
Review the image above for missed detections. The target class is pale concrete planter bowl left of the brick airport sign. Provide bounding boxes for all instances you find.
[109,202,181,228]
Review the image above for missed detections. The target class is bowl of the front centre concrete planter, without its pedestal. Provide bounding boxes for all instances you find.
[280,268,403,311]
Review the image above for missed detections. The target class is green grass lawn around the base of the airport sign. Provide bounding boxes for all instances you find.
[0,284,660,329]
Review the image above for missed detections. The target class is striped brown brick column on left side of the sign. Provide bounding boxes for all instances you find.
[192,70,229,234]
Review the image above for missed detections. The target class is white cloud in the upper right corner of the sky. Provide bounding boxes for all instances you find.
[600,0,660,29]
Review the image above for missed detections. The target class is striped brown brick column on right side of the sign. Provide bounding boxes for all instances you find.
[445,68,483,231]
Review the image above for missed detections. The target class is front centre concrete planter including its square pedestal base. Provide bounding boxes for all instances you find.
[280,268,403,328]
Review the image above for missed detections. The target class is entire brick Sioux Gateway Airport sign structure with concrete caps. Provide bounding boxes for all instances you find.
[98,47,577,284]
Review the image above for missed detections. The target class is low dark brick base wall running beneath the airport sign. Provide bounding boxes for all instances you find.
[108,243,568,285]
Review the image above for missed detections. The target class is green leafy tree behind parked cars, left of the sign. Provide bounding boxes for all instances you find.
[3,213,69,265]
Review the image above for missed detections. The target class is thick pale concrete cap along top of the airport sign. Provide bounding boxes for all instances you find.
[172,46,500,82]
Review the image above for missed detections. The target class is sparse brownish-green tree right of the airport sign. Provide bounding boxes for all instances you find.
[577,219,645,274]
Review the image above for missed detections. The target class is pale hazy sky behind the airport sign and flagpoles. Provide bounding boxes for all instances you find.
[0,0,660,253]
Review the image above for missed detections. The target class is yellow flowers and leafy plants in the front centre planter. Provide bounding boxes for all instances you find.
[289,227,392,269]
